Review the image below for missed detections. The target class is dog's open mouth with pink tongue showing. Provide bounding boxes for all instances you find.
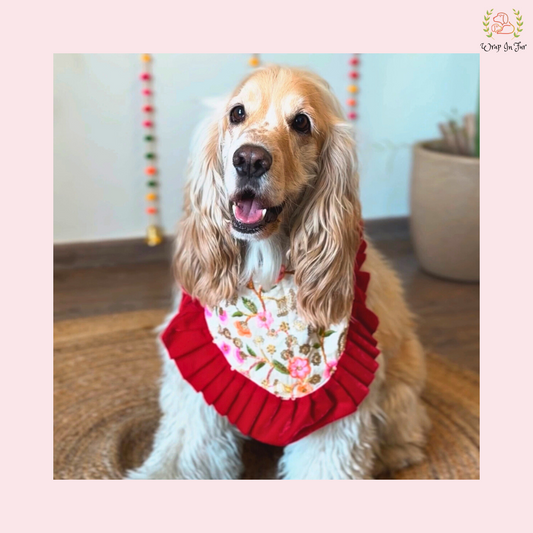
[230,191,283,233]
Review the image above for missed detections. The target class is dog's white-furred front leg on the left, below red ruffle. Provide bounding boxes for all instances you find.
[126,354,242,479]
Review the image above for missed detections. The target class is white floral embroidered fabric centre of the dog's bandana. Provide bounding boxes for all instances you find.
[205,270,348,400]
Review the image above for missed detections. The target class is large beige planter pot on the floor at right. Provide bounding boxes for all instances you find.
[411,141,479,281]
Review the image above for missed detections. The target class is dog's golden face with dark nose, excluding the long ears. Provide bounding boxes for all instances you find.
[222,70,328,240]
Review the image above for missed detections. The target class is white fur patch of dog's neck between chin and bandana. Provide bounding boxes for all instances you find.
[241,232,288,291]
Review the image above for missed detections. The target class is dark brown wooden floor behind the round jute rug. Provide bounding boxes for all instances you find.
[54,234,479,371]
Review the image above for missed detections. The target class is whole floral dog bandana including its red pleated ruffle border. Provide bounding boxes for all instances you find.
[162,240,379,446]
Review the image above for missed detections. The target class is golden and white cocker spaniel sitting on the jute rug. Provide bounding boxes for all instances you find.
[127,66,430,479]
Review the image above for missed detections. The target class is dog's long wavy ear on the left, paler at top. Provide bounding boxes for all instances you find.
[174,113,240,306]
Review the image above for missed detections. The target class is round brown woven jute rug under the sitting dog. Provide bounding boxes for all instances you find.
[54,310,479,479]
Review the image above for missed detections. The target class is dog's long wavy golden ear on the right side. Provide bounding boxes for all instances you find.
[291,120,361,327]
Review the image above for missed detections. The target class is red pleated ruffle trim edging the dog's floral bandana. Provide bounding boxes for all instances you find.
[162,241,379,446]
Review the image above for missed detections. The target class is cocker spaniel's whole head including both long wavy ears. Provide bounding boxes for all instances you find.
[175,66,360,325]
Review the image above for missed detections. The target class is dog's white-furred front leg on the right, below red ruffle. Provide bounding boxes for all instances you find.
[279,364,383,479]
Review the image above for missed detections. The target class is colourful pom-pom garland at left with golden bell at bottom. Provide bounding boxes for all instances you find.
[140,54,163,246]
